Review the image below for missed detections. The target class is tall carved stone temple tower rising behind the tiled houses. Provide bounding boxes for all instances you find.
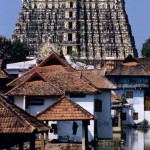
[13,0,138,67]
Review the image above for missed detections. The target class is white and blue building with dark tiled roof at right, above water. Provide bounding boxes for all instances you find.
[108,55,150,125]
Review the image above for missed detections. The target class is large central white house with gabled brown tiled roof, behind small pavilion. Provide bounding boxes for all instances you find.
[6,52,116,142]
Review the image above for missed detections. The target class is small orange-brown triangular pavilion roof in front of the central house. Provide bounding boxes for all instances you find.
[37,96,95,120]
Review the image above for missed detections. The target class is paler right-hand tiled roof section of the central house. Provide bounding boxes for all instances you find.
[82,69,117,89]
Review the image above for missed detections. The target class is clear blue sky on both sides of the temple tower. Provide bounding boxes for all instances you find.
[0,0,150,56]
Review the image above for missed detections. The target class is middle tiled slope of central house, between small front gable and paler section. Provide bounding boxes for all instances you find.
[45,72,97,93]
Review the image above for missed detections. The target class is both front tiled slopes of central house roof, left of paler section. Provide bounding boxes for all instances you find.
[6,72,97,96]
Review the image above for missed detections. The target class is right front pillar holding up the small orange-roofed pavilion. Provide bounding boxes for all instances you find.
[82,121,88,150]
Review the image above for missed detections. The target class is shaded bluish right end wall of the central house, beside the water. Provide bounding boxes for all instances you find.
[95,91,112,139]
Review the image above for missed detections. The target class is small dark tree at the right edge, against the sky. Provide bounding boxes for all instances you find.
[141,38,150,57]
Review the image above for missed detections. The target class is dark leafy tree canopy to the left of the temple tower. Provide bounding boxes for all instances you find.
[0,36,33,63]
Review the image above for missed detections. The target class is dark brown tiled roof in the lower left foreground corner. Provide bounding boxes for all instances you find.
[0,95,49,133]
